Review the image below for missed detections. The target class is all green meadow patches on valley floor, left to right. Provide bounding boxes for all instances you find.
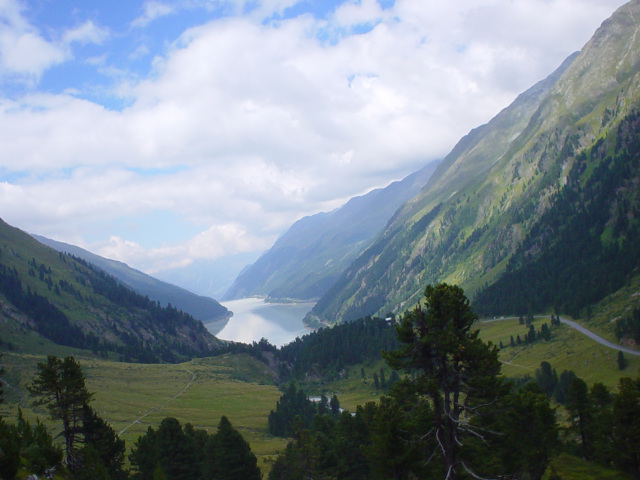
[0,310,640,479]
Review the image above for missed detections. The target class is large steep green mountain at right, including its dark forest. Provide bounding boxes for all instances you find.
[306,0,640,324]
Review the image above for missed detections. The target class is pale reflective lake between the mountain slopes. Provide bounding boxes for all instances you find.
[211,298,315,347]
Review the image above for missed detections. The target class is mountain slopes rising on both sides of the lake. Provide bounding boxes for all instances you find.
[0,0,640,354]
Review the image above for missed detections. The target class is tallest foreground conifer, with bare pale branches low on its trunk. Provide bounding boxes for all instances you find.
[384,283,503,480]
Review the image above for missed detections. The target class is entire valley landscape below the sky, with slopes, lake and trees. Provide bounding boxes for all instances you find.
[0,0,640,480]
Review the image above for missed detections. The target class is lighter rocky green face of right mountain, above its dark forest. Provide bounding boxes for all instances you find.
[308,1,640,323]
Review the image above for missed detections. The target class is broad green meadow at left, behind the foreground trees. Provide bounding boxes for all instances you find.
[0,352,287,471]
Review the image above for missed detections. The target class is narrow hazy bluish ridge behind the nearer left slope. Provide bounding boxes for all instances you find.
[32,234,231,334]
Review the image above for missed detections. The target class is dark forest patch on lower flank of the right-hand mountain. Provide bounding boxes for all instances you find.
[474,112,640,317]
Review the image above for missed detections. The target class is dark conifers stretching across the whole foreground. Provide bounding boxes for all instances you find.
[0,284,640,480]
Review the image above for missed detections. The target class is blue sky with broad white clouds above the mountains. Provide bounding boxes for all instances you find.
[0,0,625,274]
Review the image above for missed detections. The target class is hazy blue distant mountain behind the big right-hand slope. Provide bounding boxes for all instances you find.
[225,162,437,300]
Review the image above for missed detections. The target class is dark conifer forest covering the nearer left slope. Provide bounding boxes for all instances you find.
[0,252,219,363]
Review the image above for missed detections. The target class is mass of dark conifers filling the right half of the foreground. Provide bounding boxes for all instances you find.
[269,284,640,480]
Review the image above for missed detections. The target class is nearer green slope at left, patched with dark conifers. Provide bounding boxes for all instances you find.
[0,220,222,362]
